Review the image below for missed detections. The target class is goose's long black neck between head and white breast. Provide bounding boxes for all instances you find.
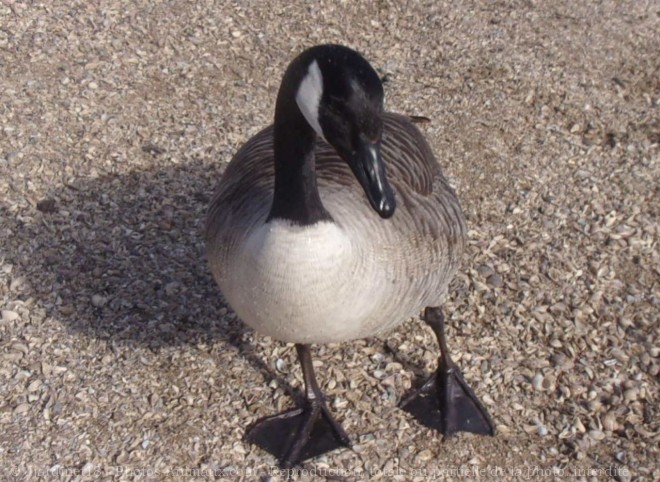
[268,58,332,226]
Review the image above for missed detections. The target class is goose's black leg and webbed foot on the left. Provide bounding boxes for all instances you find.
[245,345,350,468]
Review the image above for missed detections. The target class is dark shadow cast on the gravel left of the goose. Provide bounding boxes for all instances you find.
[0,161,297,399]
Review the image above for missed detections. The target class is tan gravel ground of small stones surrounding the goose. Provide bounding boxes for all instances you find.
[0,0,660,481]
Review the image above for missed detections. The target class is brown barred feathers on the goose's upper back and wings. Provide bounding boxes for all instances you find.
[206,113,465,277]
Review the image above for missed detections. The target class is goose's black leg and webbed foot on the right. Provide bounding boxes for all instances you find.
[400,307,495,437]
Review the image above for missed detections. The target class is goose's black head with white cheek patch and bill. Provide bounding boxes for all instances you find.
[283,45,396,218]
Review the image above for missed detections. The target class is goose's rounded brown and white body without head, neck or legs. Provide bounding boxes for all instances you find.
[207,113,465,343]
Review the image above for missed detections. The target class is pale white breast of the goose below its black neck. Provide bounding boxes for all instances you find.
[218,220,403,343]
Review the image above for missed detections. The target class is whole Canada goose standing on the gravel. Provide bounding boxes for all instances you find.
[206,45,494,467]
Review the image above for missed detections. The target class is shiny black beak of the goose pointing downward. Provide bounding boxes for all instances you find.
[349,138,396,219]
